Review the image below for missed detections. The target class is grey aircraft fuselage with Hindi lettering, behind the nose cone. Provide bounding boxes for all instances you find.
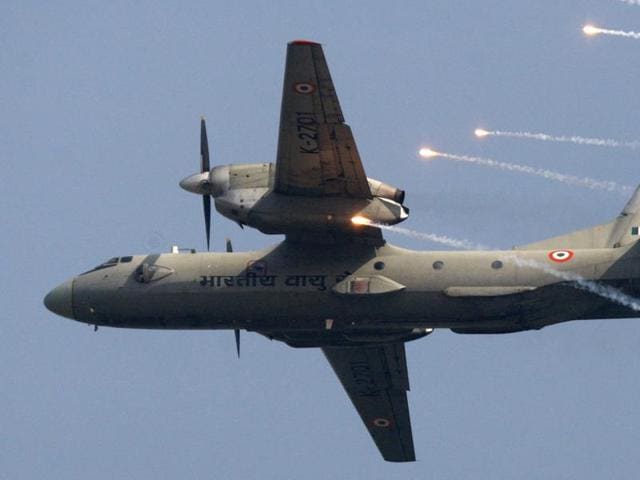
[45,241,640,342]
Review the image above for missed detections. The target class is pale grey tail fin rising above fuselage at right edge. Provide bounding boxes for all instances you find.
[514,186,640,250]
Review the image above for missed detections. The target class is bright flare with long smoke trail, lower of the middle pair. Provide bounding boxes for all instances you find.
[420,148,633,195]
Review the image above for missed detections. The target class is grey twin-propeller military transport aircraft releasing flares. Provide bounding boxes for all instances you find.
[44,41,640,462]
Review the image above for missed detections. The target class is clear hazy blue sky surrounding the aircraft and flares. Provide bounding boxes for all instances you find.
[0,0,640,479]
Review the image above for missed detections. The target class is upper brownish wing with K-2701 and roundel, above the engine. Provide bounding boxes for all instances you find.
[274,40,371,198]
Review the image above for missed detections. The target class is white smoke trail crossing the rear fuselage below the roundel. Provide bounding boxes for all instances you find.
[370,223,640,312]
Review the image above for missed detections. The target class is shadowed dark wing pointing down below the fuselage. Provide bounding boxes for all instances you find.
[322,342,416,462]
